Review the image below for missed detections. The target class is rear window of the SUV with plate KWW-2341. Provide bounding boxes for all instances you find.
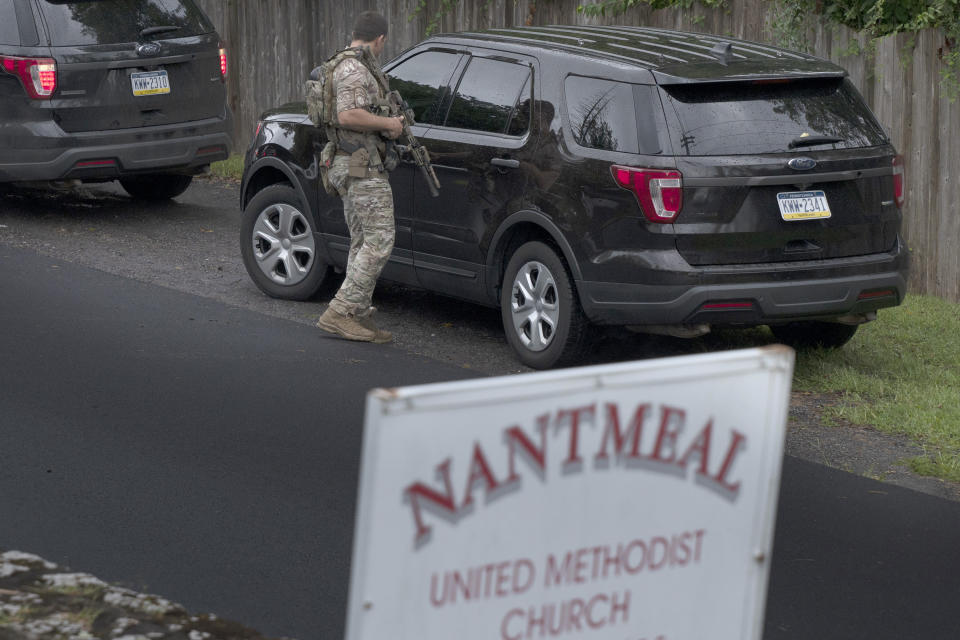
[664,78,887,156]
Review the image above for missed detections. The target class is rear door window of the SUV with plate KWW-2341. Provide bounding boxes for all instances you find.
[444,58,530,135]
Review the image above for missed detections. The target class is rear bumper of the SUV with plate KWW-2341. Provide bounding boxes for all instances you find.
[577,241,909,325]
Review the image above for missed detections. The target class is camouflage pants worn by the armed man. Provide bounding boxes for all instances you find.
[328,156,396,317]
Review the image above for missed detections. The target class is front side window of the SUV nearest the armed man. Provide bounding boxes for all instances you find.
[387,51,460,124]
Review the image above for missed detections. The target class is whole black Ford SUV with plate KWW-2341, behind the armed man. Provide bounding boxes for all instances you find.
[241,26,908,368]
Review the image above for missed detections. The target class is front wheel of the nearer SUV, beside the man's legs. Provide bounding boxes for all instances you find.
[240,184,331,300]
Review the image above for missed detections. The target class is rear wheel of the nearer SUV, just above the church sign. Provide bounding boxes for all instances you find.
[500,242,590,369]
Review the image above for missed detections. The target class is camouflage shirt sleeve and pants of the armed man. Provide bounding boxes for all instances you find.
[328,51,395,318]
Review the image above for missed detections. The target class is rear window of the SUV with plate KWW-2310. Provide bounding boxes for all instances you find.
[40,0,213,47]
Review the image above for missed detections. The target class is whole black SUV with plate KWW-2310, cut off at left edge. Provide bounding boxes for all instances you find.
[0,0,233,199]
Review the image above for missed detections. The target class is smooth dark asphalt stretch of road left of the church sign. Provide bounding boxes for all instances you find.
[0,240,469,640]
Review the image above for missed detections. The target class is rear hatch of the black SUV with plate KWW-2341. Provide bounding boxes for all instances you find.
[662,76,900,266]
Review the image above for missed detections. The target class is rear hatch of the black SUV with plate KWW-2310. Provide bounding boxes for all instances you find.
[39,0,225,133]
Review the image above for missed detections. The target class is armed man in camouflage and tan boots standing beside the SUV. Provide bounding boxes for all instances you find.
[317,11,404,343]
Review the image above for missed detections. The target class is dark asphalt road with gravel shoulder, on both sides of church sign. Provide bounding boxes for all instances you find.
[0,185,960,640]
